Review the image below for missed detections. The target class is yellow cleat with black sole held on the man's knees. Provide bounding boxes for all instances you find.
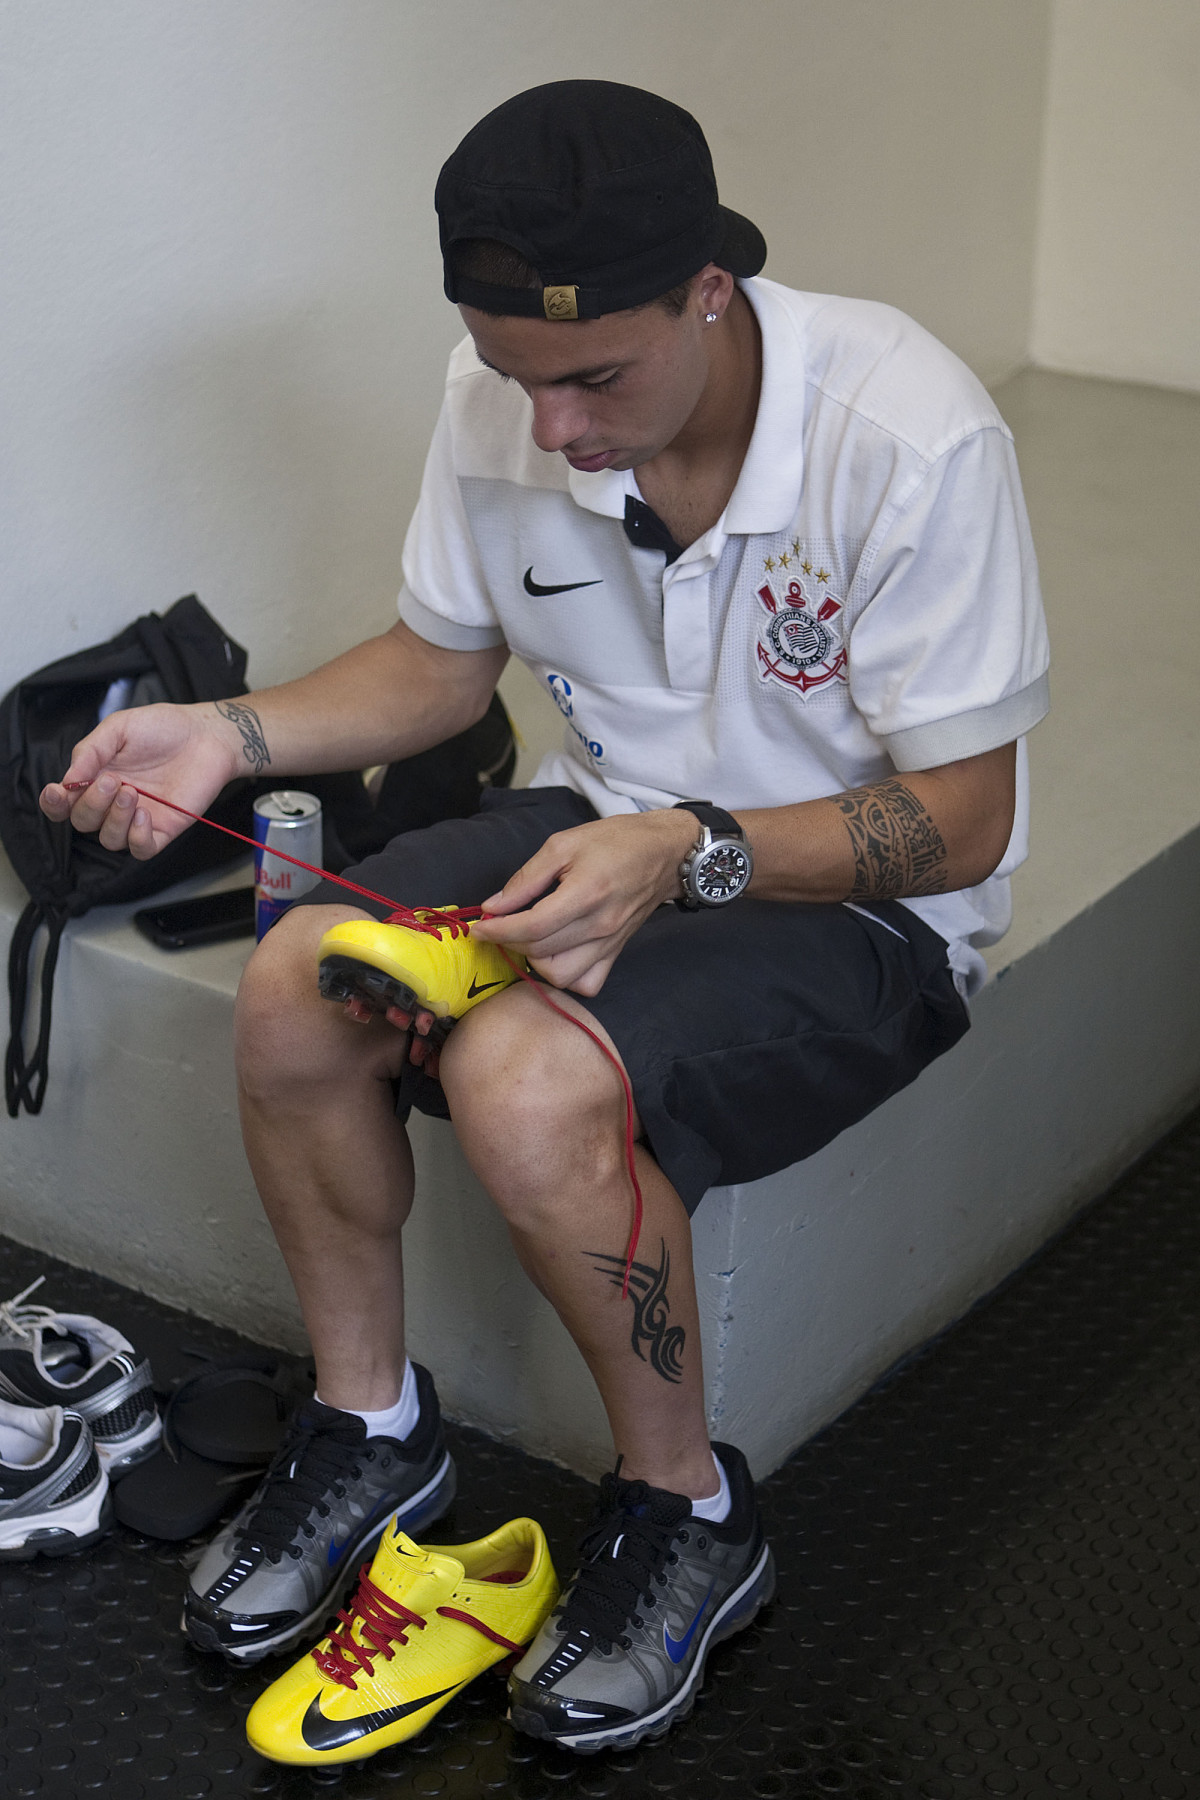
[317,907,527,1037]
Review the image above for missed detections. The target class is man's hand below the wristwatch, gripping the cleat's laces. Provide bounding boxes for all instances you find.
[471,812,698,994]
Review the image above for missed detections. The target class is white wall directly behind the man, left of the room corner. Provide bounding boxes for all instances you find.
[0,0,1047,709]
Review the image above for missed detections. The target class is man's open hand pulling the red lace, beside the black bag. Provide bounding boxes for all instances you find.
[40,702,241,862]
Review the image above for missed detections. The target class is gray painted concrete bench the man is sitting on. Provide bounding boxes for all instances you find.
[0,371,1200,1474]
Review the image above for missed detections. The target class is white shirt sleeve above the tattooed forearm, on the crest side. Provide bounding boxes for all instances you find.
[849,428,1049,770]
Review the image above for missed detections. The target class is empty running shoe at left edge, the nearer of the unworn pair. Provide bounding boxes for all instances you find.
[0,1400,112,1562]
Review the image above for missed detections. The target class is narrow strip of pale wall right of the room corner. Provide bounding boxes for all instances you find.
[1033,0,1200,389]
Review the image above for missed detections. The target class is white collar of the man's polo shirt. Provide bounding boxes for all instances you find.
[567,277,804,535]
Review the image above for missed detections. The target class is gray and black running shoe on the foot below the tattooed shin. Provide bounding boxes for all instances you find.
[509,1444,775,1753]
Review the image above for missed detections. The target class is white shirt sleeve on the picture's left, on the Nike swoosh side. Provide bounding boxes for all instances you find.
[398,398,504,650]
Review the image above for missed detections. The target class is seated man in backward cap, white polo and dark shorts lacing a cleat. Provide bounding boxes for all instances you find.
[43,81,1047,1755]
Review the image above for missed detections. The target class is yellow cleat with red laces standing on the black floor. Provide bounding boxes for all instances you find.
[246,1519,558,1764]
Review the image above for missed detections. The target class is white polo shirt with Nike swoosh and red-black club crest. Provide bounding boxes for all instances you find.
[399,277,1049,992]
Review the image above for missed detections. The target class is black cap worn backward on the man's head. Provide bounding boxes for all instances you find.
[434,81,766,319]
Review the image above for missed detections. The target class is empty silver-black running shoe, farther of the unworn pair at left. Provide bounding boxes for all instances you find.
[0,1276,162,1480]
